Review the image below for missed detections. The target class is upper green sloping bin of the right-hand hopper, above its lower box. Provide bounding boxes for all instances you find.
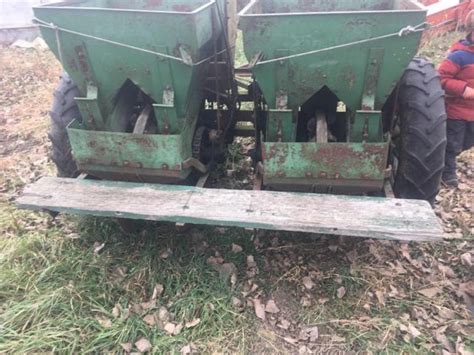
[240,0,426,112]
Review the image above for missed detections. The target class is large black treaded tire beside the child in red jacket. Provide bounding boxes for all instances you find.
[394,57,446,204]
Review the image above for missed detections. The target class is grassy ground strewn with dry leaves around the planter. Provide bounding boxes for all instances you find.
[0,35,474,354]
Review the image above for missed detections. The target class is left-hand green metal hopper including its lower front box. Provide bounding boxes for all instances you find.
[34,0,226,181]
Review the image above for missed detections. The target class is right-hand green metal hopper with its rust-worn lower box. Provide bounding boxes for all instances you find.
[240,0,426,191]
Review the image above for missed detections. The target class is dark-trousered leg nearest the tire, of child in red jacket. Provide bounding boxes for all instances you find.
[442,119,467,186]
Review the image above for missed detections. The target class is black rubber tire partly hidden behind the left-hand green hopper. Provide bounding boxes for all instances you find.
[49,72,82,177]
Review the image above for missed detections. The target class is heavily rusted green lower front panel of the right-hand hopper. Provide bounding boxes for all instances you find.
[262,143,389,182]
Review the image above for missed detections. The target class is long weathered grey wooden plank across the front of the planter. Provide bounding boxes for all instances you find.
[17,177,443,241]
